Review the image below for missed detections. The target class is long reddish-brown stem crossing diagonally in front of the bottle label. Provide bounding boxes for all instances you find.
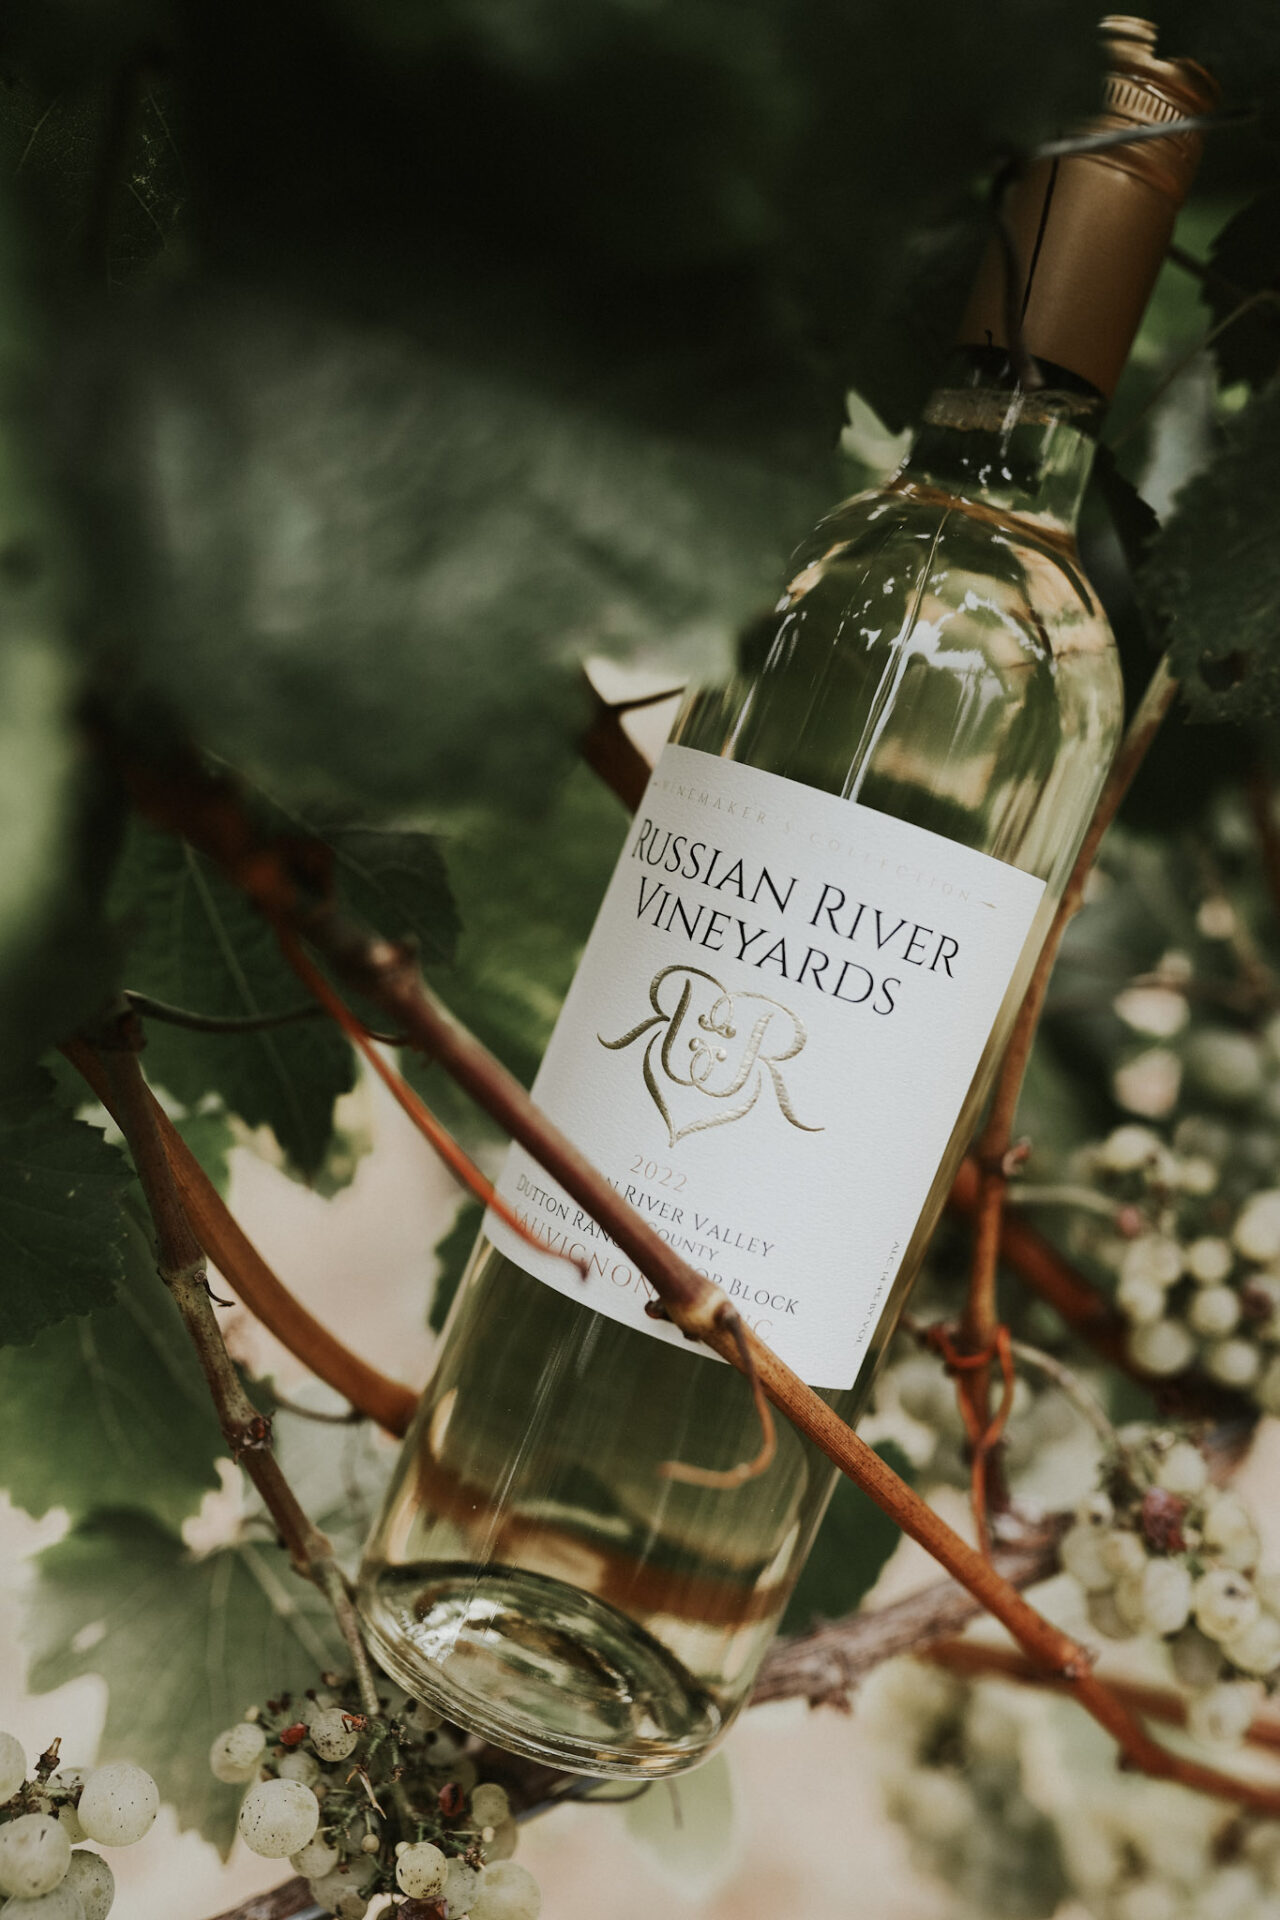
[105,729,1280,1816]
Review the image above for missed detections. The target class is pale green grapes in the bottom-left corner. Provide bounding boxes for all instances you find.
[0,1734,159,1920]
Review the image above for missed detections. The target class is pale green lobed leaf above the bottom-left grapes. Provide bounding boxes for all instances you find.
[23,1513,344,1853]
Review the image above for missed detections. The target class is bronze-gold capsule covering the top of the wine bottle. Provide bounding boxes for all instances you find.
[960,13,1219,396]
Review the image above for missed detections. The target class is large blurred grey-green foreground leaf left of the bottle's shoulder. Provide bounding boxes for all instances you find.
[67,301,821,808]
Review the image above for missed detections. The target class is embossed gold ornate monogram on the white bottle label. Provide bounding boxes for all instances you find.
[597,966,825,1146]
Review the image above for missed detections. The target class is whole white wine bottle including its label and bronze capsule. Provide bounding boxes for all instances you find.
[361,19,1215,1776]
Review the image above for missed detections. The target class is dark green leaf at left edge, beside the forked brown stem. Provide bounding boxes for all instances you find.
[0,1068,132,1346]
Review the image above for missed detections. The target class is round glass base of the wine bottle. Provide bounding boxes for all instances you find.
[359,1563,727,1780]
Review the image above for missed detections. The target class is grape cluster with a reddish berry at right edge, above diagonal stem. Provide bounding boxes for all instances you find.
[1061,1425,1280,1745]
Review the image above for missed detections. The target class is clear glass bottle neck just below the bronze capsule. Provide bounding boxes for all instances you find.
[894,348,1105,540]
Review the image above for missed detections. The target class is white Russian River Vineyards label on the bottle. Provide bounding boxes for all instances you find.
[486,747,1044,1388]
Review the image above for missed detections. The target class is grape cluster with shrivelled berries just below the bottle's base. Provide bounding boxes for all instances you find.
[209,1674,541,1920]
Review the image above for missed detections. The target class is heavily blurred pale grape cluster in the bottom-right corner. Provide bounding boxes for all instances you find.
[858,1661,1280,1920]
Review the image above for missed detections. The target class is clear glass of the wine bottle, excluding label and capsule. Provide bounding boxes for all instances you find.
[359,18,1220,1776]
